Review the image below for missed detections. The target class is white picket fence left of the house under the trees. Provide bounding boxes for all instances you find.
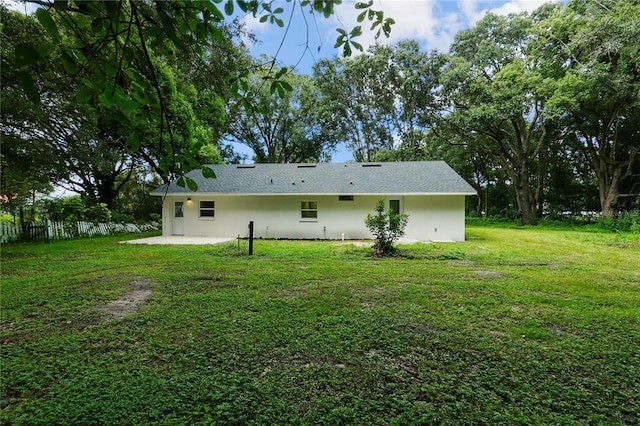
[0,220,160,243]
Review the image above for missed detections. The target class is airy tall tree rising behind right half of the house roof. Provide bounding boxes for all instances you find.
[314,41,442,161]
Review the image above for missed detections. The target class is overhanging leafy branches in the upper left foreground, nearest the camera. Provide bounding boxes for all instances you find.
[10,0,393,187]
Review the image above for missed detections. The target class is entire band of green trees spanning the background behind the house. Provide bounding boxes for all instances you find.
[0,0,640,224]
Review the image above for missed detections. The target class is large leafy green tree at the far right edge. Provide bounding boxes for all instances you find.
[537,0,640,216]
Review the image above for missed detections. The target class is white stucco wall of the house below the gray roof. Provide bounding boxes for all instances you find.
[162,195,464,241]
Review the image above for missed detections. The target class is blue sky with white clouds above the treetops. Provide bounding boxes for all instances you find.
[243,0,549,74]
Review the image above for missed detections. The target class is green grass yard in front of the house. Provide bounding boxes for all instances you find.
[0,227,640,425]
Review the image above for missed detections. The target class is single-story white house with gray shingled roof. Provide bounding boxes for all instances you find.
[151,161,476,241]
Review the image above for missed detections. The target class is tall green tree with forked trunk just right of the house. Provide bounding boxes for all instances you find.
[440,6,556,224]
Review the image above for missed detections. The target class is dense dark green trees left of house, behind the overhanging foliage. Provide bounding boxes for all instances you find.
[0,4,231,212]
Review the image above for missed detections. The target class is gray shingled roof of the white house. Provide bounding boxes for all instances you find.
[151,161,476,196]
